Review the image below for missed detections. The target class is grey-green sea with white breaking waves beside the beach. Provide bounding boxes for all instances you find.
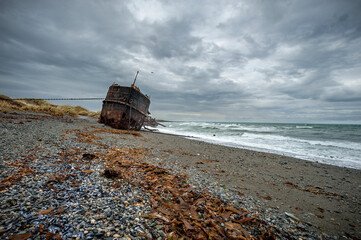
[157,122,361,170]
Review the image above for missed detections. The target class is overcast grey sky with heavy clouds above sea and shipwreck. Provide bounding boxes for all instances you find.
[0,0,361,123]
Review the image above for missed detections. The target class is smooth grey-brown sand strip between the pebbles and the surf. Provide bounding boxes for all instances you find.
[134,132,361,238]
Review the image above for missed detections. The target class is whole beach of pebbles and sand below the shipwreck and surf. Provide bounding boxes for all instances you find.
[0,113,361,239]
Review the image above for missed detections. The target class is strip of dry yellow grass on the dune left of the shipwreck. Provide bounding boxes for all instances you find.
[0,95,100,117]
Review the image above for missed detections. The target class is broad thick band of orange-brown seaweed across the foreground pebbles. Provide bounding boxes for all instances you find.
[104,148,276,239]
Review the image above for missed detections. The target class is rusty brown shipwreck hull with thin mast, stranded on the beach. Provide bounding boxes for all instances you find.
[99,71,150,131]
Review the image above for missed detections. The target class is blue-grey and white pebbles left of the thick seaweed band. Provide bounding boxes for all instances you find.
[0,113,153,239]
